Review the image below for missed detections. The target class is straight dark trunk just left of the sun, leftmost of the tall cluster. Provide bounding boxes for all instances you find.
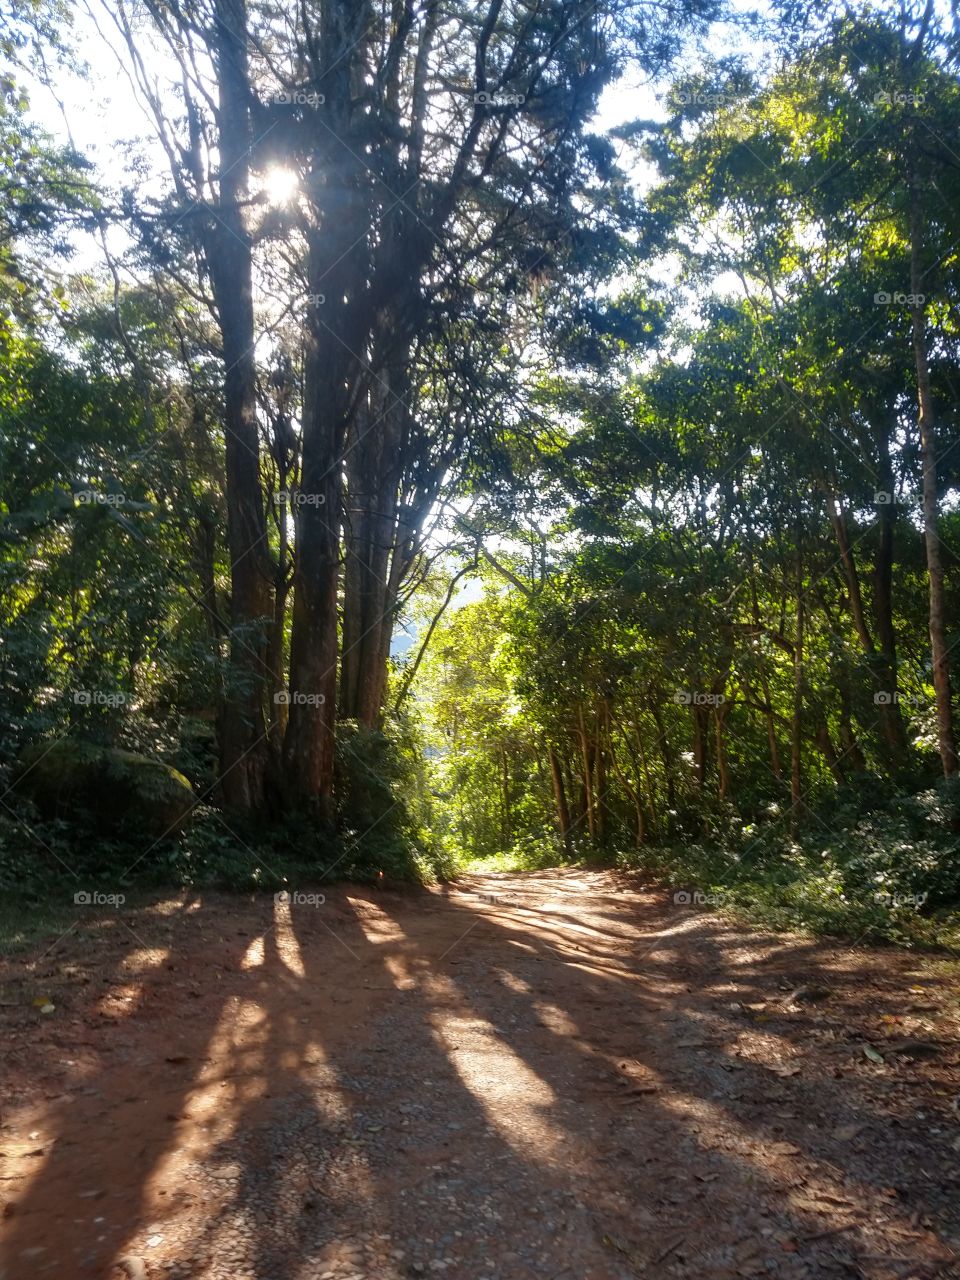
[206,0,273,812]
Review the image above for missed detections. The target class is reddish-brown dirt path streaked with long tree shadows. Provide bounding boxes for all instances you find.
[0,870,960,1280]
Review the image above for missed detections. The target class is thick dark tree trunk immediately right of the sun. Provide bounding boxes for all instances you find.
[283,0,374,818]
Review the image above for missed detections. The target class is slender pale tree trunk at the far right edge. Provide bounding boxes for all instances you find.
[910,178,957,778]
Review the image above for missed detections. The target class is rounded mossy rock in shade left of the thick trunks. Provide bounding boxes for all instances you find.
[15,737,195,841]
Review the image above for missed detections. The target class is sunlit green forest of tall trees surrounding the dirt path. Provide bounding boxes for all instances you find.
[0,0,960,940]
